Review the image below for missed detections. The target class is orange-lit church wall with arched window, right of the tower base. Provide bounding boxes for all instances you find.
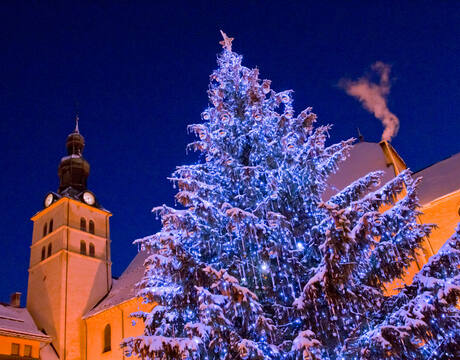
[82,298,152,360]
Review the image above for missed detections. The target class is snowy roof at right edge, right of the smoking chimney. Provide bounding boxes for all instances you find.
[414,153,460,205]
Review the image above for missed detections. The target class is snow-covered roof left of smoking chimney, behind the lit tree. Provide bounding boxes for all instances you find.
[323,141,395,200]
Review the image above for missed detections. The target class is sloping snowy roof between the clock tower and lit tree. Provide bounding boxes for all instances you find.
[84,252,147,318]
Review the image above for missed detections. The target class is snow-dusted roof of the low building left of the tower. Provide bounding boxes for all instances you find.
[0,303,51,342]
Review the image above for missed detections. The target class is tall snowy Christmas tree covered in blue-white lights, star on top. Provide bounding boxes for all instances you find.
[125,34,458,359]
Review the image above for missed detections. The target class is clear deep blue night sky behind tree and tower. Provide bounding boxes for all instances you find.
[0,1,460,301]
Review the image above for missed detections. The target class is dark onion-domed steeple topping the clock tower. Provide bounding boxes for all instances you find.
[58,115,90,196]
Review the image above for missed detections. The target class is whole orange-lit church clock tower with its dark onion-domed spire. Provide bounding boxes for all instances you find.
[27,117,112,360]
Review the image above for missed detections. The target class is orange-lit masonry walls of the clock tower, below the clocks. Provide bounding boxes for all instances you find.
[27,198,112,360]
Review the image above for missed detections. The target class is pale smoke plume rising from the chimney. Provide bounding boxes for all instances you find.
[339,61,399,141]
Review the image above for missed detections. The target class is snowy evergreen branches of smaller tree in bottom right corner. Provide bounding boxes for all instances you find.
[351,225,460,359]
